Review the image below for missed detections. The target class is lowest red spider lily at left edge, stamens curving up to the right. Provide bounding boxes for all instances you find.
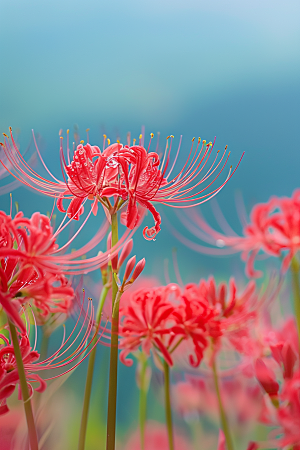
[0,294,101,415]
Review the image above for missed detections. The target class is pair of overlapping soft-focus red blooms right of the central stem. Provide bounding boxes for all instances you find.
[120,278,257,367]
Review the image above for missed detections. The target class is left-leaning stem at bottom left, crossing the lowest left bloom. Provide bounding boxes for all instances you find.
[8,320,39,450]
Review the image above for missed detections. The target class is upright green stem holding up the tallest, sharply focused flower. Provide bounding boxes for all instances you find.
[106,214,121,450]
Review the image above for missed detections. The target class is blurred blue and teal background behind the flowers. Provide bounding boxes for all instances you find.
[0,0,300,450]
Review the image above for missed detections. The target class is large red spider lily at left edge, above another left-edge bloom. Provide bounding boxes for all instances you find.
[0,211,128,333]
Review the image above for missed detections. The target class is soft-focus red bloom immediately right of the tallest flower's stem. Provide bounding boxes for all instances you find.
[120,284,227,367]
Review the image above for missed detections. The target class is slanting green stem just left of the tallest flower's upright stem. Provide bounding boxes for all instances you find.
[78,286,109,450]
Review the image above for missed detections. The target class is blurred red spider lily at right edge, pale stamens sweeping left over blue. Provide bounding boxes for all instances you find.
[172,189,300,277]
